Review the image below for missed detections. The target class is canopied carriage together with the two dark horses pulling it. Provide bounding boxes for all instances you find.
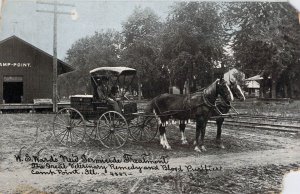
[53,67,245,151]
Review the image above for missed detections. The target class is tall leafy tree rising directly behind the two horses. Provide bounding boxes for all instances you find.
[159,2,227,90]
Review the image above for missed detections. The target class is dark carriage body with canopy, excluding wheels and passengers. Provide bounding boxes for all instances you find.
[70,67,137,120]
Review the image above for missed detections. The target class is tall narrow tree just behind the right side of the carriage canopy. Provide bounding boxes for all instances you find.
[121,7,167,98]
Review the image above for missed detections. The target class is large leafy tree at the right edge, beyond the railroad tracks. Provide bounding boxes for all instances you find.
[227,2,300,98]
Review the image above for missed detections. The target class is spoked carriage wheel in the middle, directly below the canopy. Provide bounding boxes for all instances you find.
[97,111,128,149]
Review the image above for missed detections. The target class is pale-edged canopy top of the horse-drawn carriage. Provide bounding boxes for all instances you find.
[90,67,136,76]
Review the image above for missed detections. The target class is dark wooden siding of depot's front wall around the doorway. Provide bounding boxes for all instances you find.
[0,37,52,103]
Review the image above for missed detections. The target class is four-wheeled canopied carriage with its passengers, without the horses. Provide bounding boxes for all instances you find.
[53,67,158,148]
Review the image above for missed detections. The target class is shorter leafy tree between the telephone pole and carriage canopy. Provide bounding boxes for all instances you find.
[58,30,122,96]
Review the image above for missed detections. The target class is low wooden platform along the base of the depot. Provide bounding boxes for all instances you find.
[0,102,70,112]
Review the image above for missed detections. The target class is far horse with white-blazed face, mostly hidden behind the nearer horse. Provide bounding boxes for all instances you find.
[212,81,245,149]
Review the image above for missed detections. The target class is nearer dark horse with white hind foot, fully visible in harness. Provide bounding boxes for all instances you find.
[145,78,233,151]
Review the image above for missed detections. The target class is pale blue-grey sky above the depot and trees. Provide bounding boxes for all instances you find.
[0,0,173,60]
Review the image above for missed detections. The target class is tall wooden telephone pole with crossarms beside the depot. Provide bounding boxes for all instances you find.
[36,0,75,113]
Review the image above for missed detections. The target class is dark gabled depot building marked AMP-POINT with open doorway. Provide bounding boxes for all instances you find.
[0,36,74,104]
